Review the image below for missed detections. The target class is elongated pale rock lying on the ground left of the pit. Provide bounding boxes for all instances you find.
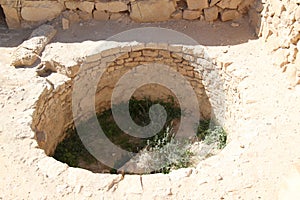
[11,25,56,67]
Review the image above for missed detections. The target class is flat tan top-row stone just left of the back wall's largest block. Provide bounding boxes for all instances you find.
[96,1,128,13]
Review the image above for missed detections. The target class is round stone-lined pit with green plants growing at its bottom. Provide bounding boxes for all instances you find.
[32,43,227,174]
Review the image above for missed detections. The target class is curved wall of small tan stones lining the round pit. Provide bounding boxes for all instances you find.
[31,41,239,155]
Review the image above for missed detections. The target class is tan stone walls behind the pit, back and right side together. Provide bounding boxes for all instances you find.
[0,0,300,85]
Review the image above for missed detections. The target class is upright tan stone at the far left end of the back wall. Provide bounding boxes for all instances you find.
[1,5,21,29]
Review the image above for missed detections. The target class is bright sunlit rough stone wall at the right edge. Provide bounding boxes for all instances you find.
[250,0,300,86]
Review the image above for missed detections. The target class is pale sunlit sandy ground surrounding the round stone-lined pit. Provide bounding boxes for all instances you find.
[0,16,300,199]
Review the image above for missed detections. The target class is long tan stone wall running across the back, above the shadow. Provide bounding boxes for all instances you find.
[0,0,251,28]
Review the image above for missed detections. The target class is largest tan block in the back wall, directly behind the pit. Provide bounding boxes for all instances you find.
[130,0,176,22]
